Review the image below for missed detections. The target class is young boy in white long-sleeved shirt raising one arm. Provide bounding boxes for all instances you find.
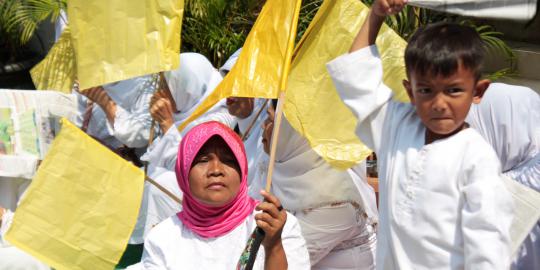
[328,0,512,269]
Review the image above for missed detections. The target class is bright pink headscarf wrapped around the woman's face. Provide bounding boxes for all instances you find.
[176,121,258,238]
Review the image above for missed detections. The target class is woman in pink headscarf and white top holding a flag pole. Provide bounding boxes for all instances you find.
[142,122,309,270]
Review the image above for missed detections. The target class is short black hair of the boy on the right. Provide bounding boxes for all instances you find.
[405,22,484,80]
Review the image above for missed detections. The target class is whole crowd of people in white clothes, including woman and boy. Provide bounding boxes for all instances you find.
[0,0,540,270]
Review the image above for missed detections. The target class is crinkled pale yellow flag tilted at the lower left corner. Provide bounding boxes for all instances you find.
[6,119,144,269]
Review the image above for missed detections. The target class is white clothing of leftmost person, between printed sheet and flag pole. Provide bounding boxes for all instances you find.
[74,75,155,148]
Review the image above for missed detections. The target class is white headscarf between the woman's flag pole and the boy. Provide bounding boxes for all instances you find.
[272,107,377,219]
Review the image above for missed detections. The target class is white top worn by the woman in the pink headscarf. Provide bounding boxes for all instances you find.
[137,212,310,270]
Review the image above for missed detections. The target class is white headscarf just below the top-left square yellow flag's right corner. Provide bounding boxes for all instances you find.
[165,53,222,122]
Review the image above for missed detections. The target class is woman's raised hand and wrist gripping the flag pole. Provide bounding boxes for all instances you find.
[255,191,287,252]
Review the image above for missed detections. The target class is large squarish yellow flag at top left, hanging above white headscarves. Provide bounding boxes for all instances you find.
[68,0,184,89]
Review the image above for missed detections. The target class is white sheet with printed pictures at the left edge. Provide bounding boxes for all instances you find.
[0,89,78,179]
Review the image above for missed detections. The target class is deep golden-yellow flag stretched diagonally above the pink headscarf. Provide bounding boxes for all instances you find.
[178,0,302,130]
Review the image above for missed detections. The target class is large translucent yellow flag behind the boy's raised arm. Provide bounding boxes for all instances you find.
[284,0,407,169]
